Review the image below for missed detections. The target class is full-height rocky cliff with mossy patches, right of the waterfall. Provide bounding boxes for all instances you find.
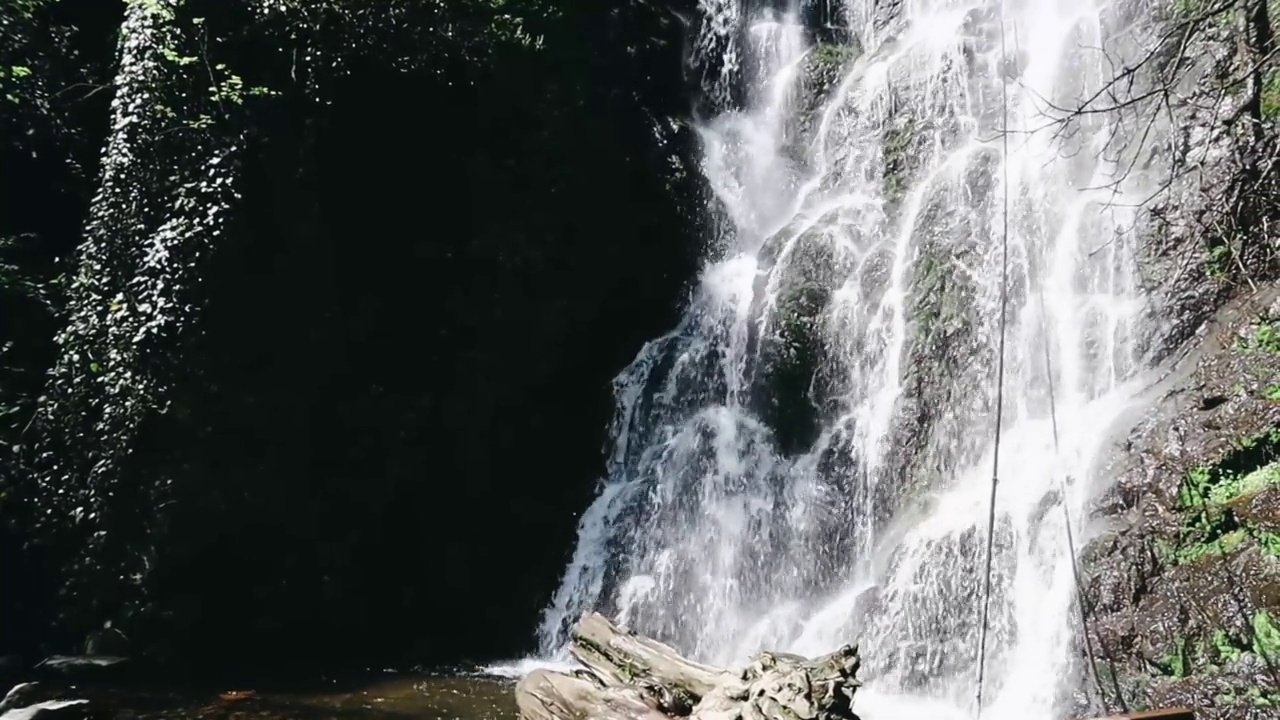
[1083,1,1280,717]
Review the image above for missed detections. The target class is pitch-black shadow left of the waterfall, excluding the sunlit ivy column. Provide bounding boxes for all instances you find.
[0,1,699,671]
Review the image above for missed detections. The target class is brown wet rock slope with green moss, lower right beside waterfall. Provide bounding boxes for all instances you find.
[1083,288,1280,719]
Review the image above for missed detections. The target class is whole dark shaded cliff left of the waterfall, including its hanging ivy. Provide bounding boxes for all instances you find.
[0,0,700,666]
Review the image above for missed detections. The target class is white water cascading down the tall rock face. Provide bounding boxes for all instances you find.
[529,0,1160,717]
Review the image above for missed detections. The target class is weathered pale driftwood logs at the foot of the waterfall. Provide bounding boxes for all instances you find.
[516,612,860,720]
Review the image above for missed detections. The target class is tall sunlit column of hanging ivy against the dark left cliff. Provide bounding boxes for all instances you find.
[29,0,243,632]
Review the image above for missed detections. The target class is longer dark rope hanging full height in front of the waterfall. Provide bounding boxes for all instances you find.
[975,0,1009,716]
